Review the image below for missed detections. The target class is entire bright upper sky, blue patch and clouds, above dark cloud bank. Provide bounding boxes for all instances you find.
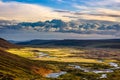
[0,0,120,22]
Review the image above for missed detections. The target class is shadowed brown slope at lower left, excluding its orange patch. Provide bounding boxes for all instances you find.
[0,50,46,80]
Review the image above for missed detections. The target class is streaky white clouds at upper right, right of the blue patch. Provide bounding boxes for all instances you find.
[73,0,120,22]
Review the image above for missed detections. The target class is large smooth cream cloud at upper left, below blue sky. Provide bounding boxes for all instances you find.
[0,1,69,21]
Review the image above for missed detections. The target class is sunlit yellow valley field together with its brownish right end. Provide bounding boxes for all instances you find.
[7,47,119,63]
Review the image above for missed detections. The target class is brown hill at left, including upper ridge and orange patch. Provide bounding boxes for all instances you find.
[0,38,51,80]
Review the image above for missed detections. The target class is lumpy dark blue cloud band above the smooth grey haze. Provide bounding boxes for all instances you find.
[0,19,120,36]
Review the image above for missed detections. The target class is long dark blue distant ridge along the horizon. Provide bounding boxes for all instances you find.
[16,39,120,48]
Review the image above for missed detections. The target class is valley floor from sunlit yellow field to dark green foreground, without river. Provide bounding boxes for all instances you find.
[3,47,120,80]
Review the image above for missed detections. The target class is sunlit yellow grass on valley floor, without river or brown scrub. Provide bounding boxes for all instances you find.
[7,47,118,63]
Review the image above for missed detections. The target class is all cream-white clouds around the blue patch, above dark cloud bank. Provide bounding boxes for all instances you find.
[0,0,120,21]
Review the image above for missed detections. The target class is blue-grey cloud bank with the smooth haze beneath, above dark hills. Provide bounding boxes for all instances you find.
[0,19,120,41]
